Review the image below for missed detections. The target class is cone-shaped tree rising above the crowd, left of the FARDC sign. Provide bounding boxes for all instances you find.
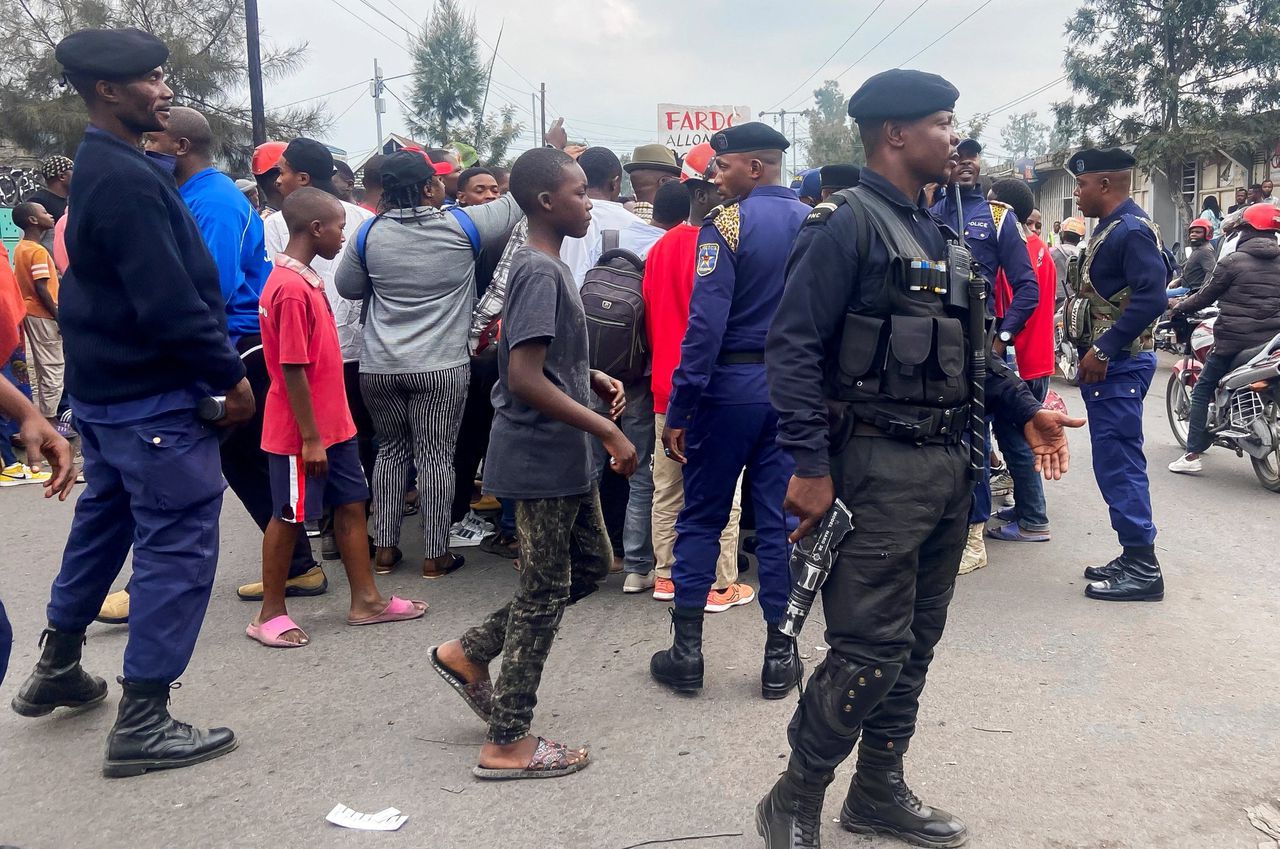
[404,0,524,165]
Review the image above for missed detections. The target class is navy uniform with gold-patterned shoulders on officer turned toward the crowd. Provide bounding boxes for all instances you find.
[667,186,810,624]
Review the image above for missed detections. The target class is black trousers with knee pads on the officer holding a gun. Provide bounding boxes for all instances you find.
[788,437,973,780]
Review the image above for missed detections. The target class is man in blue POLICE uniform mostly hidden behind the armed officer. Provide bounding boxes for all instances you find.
[929,138,1039,575]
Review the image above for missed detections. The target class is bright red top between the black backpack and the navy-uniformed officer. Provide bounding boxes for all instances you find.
[644,222,699,414]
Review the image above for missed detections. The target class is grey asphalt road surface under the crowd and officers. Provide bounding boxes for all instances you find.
[0,370,1280,849]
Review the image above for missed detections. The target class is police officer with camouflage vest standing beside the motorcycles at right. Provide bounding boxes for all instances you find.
[1066,147,1170,602]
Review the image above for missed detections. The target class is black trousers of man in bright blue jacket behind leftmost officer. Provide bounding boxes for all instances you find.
[220,336,316,578]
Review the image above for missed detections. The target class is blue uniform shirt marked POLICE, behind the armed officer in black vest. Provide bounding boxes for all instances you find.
[929,188,1039,336]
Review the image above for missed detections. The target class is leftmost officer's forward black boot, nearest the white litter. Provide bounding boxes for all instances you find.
[102,679,236,779]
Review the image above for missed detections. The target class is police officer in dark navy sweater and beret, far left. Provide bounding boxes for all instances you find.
[13,29,253,777]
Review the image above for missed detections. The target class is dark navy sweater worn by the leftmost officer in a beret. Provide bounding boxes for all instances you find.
[59,127,244,403]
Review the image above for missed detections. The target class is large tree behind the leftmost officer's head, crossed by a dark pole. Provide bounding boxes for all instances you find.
[0,0,329,170]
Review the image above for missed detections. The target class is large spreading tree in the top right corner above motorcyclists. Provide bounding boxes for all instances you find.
[1056,0,1280,215]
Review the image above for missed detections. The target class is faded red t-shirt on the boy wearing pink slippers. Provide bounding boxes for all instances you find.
[257,254,356,456]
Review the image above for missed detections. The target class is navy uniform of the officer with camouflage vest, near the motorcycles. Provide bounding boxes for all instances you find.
[1080,200,1169,547]
